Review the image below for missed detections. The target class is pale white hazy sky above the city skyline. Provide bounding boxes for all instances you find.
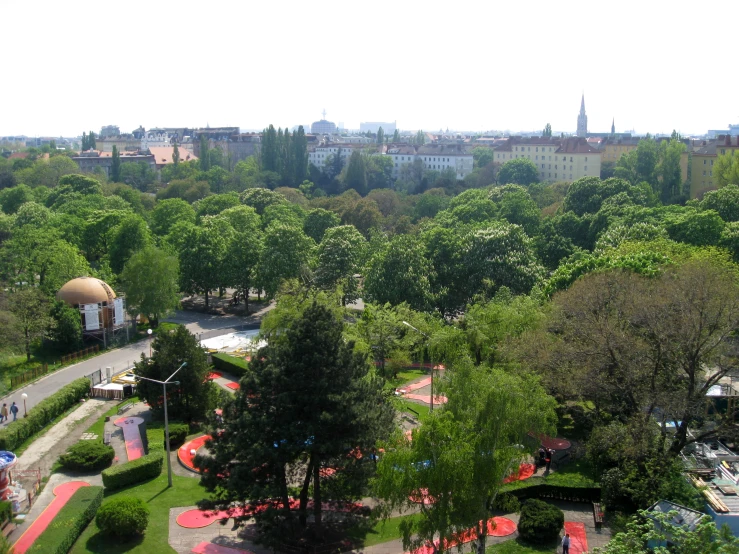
[0,0,739,136]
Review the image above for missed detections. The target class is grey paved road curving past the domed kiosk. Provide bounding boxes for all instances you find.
[0,307,269,416]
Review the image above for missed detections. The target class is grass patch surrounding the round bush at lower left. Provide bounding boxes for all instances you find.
[70,472,208,554]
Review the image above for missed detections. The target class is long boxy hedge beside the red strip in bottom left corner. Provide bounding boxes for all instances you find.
[26,484,103,554]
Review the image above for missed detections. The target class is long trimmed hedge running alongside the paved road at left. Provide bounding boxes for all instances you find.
[0,377,90,451]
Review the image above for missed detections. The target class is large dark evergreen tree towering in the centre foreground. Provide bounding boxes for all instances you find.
[198,297,393,540]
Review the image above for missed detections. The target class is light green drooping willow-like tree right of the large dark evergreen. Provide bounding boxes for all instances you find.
[374,359,556,553]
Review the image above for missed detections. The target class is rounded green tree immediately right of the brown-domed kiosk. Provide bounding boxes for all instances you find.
[121,246,180,326]
